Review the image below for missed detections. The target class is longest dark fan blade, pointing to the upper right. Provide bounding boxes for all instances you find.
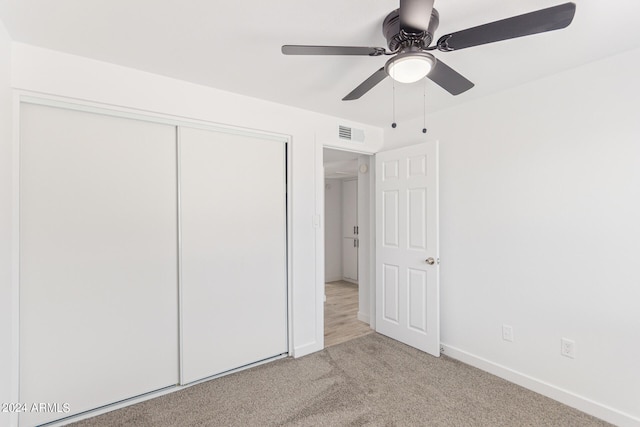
[437,3,576,51]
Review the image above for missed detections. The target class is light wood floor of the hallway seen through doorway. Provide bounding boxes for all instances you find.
[324,280,373,347]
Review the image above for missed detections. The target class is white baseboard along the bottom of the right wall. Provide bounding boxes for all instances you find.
[441,344,640,427]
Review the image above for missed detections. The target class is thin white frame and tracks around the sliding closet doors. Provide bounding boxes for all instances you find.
[9,89,293,425]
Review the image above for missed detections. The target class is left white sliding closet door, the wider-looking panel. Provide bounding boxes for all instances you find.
[20,104,178,426]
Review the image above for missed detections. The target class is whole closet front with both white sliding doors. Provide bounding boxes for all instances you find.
[19,102,288,426]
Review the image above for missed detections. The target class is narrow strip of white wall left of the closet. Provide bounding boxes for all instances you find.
[0,16,12,425]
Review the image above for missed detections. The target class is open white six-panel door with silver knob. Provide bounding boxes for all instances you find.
[376,142,440,356]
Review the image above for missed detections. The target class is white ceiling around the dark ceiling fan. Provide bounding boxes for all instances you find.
[0,0,640,126]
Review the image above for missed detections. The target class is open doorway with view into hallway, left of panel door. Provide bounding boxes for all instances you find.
[323,148,373,347]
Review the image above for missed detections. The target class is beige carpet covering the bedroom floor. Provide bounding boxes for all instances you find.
[74,333,608,427]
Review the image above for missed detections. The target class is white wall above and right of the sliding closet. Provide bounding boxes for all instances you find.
[3,43,382,364]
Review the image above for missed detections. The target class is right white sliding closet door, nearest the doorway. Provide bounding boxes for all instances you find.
[180,128,287,383]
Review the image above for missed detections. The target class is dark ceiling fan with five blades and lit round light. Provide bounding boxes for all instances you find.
[282,0,576,101]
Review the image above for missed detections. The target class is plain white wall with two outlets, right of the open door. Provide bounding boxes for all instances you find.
[385,50,640,425]
